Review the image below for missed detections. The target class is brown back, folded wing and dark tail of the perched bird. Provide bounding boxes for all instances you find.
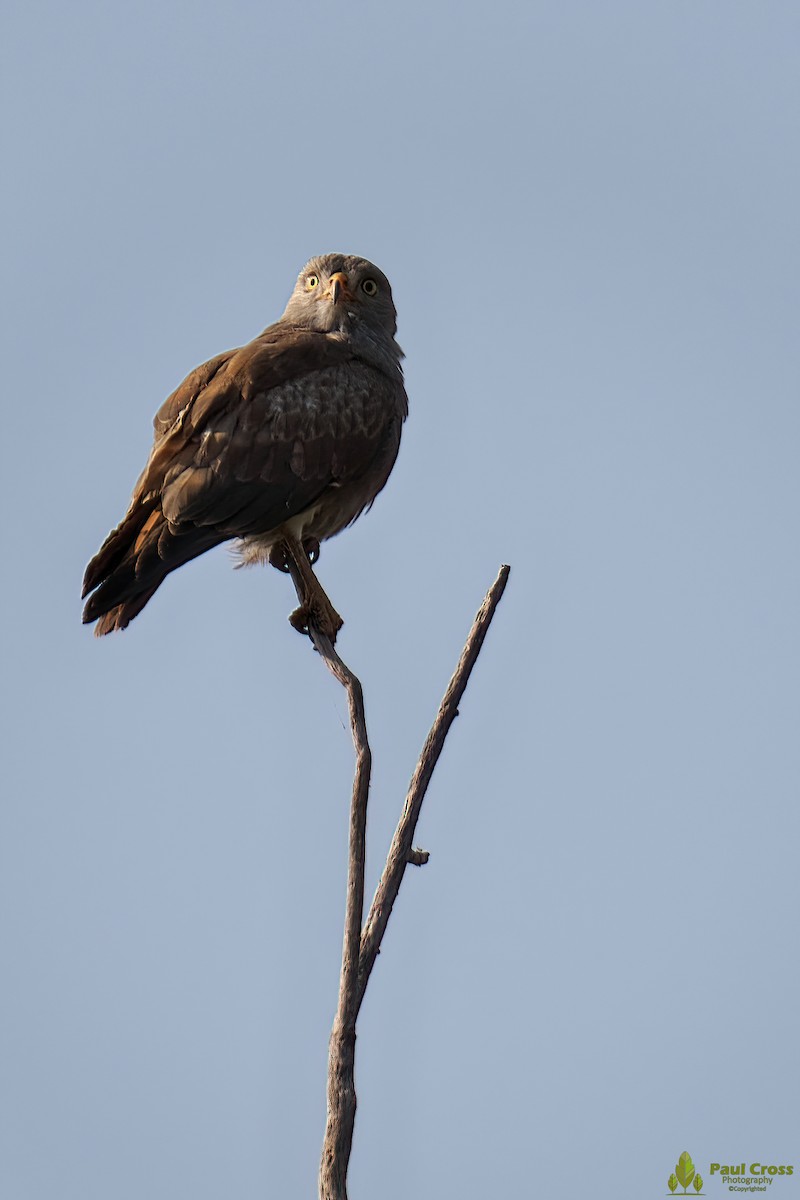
[84,323,405,634]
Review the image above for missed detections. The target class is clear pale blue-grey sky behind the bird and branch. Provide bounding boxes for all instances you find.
[0,0,800,1200]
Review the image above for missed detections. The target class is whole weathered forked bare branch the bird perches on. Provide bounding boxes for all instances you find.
[278,544,510,1200]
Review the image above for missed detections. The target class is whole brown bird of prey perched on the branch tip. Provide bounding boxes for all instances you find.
[83,254,408,638]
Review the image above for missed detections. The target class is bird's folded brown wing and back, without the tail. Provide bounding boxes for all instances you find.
[132,323,404,535]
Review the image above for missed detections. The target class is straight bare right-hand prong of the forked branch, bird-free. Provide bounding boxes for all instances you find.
[357,566,511,1008]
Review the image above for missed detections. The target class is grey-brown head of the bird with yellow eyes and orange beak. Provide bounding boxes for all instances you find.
[283,254,397,338]
